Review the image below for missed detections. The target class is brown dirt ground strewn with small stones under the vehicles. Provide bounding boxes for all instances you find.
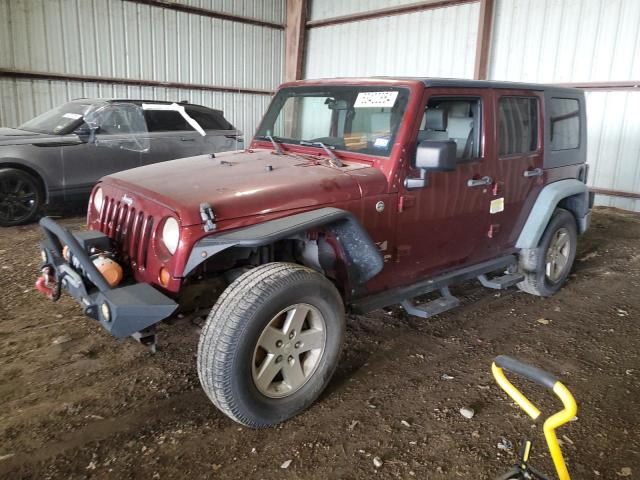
[0,209,640,479]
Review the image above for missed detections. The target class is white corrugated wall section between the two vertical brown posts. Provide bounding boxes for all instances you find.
[305,0,479,78]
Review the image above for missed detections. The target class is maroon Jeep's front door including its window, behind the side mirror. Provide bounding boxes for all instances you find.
[396,89,493,284]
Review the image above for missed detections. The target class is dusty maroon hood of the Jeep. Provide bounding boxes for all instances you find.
[104,150,386,225]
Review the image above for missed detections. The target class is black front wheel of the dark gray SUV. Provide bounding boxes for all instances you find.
[0,168,42,227]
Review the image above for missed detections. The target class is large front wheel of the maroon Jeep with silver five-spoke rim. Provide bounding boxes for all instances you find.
[198,263,345,428]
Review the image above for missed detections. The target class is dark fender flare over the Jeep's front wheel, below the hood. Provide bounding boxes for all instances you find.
[182,207,384,285]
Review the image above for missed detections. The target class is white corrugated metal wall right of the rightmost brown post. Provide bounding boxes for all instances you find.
[490,0,640,211]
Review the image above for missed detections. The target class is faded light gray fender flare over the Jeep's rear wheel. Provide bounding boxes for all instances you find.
[516,178,590,249]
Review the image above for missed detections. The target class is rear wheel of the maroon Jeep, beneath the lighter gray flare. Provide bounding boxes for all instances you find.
[518,208,578,297]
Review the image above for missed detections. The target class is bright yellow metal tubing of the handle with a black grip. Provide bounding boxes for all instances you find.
[491,363,578,480]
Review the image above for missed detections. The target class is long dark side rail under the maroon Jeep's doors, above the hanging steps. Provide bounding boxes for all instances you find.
[349,255,518,314]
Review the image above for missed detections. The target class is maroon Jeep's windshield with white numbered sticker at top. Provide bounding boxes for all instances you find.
[256,85,409,157]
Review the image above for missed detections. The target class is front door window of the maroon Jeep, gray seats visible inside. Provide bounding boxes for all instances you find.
[418,97,482,163]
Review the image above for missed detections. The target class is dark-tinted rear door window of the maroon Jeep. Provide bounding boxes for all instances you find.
[498,97,539,157]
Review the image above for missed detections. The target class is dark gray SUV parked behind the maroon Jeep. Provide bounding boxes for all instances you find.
[0,99,243,226]
